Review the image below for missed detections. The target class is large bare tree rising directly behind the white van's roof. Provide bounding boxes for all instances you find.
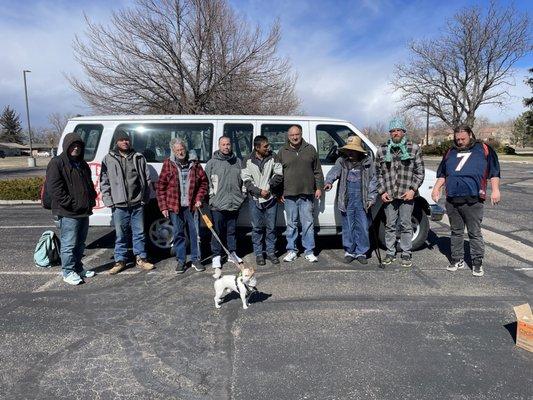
[68,0,299,114]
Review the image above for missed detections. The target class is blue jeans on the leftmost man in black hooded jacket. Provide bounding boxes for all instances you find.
[59,217,89,276]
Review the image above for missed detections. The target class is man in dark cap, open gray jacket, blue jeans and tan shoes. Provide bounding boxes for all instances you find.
[100,130,154,275]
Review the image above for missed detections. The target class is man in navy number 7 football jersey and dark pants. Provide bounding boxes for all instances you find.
[431,125,500,276]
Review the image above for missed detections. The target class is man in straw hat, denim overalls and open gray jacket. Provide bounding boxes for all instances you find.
[324,136,378,264]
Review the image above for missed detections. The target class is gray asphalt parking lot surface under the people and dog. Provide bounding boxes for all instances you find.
[0,161,533,399]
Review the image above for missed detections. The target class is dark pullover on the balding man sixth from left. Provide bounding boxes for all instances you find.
[278,139,324,196]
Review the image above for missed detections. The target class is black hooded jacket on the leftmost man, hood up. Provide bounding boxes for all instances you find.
[46,133,96,218]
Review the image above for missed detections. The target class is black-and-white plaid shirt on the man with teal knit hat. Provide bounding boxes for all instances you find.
[376,142,424,199]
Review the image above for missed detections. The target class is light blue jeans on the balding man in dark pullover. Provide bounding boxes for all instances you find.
[285,196,315,255]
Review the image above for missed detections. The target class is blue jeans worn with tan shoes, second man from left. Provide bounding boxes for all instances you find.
[113,205,146,262]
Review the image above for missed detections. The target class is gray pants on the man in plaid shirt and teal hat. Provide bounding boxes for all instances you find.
[385,199,414,256]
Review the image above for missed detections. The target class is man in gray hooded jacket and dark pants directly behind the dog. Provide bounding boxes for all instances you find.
[205,136,245,279]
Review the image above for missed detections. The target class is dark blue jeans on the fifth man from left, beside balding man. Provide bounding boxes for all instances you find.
[250,200,278,256]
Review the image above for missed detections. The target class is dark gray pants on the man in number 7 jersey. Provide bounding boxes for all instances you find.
[446,201,485,262]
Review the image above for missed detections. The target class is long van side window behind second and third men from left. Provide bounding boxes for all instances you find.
[111,123,214,162]
